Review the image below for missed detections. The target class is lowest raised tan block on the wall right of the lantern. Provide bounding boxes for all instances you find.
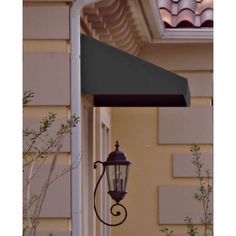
[159,185,212,224]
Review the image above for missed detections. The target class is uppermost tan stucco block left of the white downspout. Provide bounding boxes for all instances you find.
[23,6,69,39]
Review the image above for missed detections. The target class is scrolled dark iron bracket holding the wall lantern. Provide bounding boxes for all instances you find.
[94,161,128,226]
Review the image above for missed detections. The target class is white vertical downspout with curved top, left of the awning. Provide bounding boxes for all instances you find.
[70,0,102,236]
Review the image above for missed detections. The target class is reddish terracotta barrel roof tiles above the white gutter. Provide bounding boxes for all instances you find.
[156,0,213,28]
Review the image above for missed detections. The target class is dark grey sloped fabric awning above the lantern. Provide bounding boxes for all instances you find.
[81,35,190,107]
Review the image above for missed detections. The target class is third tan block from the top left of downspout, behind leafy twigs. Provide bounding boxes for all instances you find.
[23,118,70,152]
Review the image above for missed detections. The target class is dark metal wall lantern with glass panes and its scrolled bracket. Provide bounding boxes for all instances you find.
[94,141,131,226]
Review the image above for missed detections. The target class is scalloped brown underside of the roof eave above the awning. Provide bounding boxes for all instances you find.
[82,0,144,54]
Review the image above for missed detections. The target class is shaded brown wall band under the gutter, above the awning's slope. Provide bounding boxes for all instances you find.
[139,43,213,71]
